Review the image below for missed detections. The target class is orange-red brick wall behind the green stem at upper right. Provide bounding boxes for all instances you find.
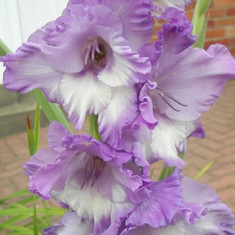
[153,0,235,56]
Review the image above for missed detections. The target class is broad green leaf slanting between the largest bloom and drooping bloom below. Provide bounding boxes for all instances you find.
[32,89,72,133]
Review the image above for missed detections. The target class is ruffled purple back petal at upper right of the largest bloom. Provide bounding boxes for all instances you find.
[69,0,153,51]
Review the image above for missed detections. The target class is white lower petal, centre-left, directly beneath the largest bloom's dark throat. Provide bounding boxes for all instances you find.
[59,71,112,129]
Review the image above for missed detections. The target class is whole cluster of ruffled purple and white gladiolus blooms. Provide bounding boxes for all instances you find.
[0,0,235,235]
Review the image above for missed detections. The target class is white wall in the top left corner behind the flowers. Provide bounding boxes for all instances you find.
[0,0,68,84]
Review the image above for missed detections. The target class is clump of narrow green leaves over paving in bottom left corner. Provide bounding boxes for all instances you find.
[0,189,65,235]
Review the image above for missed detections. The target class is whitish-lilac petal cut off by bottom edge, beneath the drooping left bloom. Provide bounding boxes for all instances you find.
[43,211,93,235]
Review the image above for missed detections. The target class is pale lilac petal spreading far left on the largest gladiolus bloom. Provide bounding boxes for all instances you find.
[0,42,63,103]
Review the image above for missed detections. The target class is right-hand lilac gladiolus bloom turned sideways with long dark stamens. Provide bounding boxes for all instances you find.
[124,8,235,168]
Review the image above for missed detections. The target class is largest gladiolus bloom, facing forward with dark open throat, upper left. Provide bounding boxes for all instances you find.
[0,0,153,145]
